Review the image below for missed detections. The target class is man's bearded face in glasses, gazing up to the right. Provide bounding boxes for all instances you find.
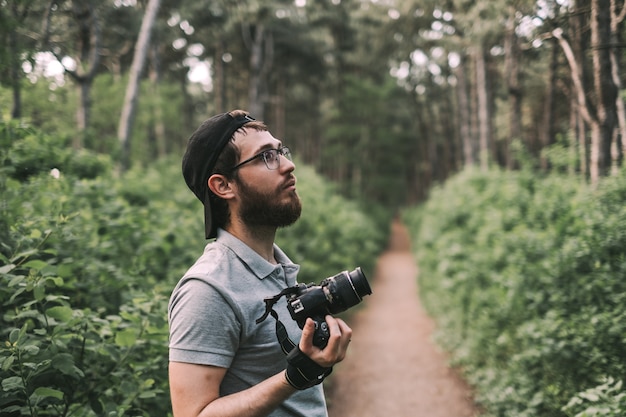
[236,129,302,227]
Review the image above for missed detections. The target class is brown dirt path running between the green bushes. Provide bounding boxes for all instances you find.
[328,219,478,417]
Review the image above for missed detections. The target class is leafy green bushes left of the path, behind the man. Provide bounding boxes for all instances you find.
[0,123,386,416]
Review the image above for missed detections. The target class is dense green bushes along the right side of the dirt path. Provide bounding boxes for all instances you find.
[405,164,626,417]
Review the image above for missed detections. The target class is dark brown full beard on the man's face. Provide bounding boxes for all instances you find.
[239,176,302,227]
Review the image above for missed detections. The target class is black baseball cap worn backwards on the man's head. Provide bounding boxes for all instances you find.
[183,113,255,239]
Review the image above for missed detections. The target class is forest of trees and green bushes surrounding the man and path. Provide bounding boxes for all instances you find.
[0,0,626,417]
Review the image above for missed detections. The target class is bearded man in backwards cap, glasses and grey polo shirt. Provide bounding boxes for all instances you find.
[169,110,352,417]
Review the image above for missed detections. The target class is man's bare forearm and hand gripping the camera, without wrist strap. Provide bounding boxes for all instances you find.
[169,316,352,417]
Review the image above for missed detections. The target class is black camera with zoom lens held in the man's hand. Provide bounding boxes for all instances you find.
[287,267,372,349]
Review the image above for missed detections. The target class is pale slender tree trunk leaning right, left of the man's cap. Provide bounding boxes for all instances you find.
[117,0,160,172]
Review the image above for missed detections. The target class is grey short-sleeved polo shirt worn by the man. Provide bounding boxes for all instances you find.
[169,229,327,417]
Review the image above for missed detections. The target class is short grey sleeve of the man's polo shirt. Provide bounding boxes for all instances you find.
[169,278,241,368]
